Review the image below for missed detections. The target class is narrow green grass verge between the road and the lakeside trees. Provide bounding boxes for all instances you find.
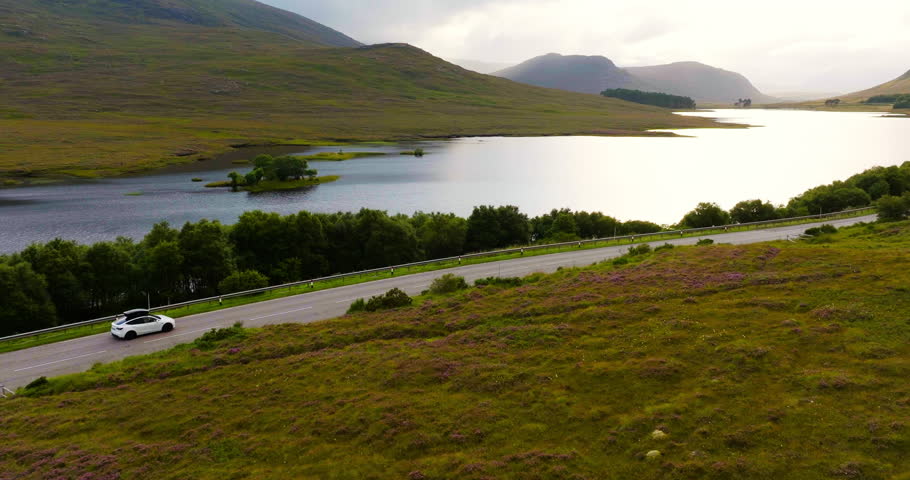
[0,211,869,353]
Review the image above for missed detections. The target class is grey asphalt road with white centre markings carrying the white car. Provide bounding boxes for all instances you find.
[0,215,875,389]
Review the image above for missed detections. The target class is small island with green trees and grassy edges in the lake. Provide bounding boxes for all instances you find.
[206,155,341,193]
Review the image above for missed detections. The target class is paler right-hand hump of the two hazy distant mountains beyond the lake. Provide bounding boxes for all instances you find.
[626,62,776,104]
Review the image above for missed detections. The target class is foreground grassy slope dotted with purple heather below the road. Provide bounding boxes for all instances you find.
[0,223,910,480]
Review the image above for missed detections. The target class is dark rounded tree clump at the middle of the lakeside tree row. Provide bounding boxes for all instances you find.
[466,205,530,251]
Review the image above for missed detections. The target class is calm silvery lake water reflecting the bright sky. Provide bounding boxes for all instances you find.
[0,110,910,252]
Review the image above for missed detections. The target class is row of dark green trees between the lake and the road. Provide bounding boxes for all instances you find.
[0,162,910,336]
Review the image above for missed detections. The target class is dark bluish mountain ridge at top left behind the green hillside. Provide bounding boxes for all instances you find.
[0,0,362,47]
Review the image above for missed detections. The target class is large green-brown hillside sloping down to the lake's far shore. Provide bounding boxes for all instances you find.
[0,0,712,186]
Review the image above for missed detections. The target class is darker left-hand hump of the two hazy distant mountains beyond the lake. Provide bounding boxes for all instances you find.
[493,53,647,94]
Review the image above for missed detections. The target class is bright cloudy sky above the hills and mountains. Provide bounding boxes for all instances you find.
[264,0,910,93]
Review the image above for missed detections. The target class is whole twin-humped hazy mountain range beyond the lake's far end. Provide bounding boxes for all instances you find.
[493,53,776,103]
